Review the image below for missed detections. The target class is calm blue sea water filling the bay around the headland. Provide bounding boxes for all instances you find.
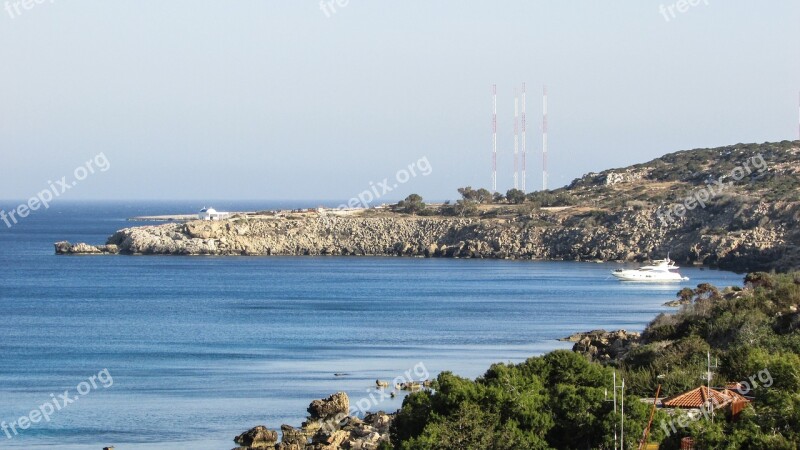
[0,202,742,450]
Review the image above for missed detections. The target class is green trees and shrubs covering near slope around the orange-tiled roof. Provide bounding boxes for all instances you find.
[392,272,800,450]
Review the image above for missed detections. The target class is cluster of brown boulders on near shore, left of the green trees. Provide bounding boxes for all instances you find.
[234,392,394,450]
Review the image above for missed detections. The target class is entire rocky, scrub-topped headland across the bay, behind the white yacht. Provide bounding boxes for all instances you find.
[56,141,800,272]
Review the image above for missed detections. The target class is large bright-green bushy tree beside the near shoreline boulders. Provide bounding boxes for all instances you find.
[392,351,649,450]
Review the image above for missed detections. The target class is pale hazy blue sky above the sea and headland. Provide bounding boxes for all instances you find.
[0,0,800,199]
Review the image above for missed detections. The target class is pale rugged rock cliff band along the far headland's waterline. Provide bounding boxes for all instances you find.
[55,202,798,272]
